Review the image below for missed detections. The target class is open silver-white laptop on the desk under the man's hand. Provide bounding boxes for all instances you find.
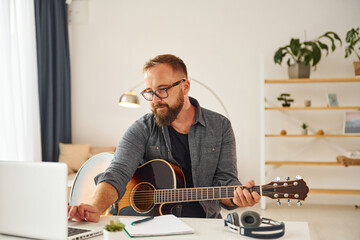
[0,161,102,239]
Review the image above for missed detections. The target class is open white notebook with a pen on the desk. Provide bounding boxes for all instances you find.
[120,214,194,237]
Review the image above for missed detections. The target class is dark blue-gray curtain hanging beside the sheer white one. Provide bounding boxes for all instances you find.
[35,0,71,162]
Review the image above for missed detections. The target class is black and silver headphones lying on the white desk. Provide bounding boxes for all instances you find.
[224,211,285,239]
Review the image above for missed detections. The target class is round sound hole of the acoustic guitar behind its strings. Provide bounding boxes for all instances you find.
[131,183,154,212]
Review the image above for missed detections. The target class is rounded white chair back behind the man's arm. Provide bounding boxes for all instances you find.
[69,153,114,206]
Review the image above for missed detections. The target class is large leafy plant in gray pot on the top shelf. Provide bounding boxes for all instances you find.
[274,32,342,78]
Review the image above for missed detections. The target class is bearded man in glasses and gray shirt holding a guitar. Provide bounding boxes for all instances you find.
[68,54,260,222]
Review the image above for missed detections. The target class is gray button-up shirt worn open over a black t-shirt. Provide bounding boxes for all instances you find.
[95,97,240,218]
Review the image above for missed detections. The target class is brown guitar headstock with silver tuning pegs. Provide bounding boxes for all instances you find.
[262,179,309,201]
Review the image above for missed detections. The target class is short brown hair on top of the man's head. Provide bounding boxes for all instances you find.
[143,54,188,78]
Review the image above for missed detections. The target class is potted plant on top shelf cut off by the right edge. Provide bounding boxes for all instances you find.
[345,28,360,76]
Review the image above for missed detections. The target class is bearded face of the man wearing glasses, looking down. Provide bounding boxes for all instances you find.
[145,64,185,126]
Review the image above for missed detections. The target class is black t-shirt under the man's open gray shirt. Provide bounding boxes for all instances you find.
[168,126,206,217]
